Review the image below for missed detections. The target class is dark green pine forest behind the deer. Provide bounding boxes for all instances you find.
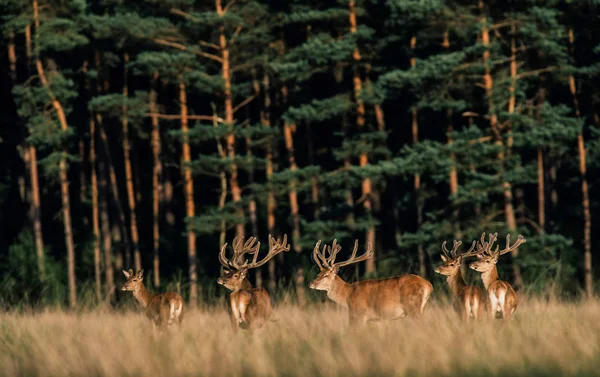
[0,0,600,308]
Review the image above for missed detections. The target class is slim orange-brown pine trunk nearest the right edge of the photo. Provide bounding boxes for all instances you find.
[569,28,594,299]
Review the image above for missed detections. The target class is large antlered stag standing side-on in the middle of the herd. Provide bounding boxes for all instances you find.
[309,239,433,326]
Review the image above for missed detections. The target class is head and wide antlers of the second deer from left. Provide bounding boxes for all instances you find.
[217,234,290,291]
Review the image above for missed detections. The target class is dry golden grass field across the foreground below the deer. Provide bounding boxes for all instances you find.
[0,301,600,377]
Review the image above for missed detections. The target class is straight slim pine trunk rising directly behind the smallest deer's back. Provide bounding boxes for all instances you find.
[149,72,162,287]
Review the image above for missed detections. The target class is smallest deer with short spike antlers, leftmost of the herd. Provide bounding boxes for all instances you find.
[121,269,183,329]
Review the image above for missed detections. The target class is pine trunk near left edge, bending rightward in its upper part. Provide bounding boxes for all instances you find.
[33,0,77,308]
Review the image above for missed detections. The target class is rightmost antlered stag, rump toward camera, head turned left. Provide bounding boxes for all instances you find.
[469,233,525,320]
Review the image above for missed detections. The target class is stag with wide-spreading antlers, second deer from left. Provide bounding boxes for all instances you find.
[217,235,290,332]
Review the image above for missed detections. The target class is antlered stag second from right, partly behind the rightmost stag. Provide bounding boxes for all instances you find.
[435,240,485,321]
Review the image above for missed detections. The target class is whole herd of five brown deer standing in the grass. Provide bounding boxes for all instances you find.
[122,233,525,331]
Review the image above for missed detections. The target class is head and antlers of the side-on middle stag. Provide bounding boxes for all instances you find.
[308,240,373,291]
